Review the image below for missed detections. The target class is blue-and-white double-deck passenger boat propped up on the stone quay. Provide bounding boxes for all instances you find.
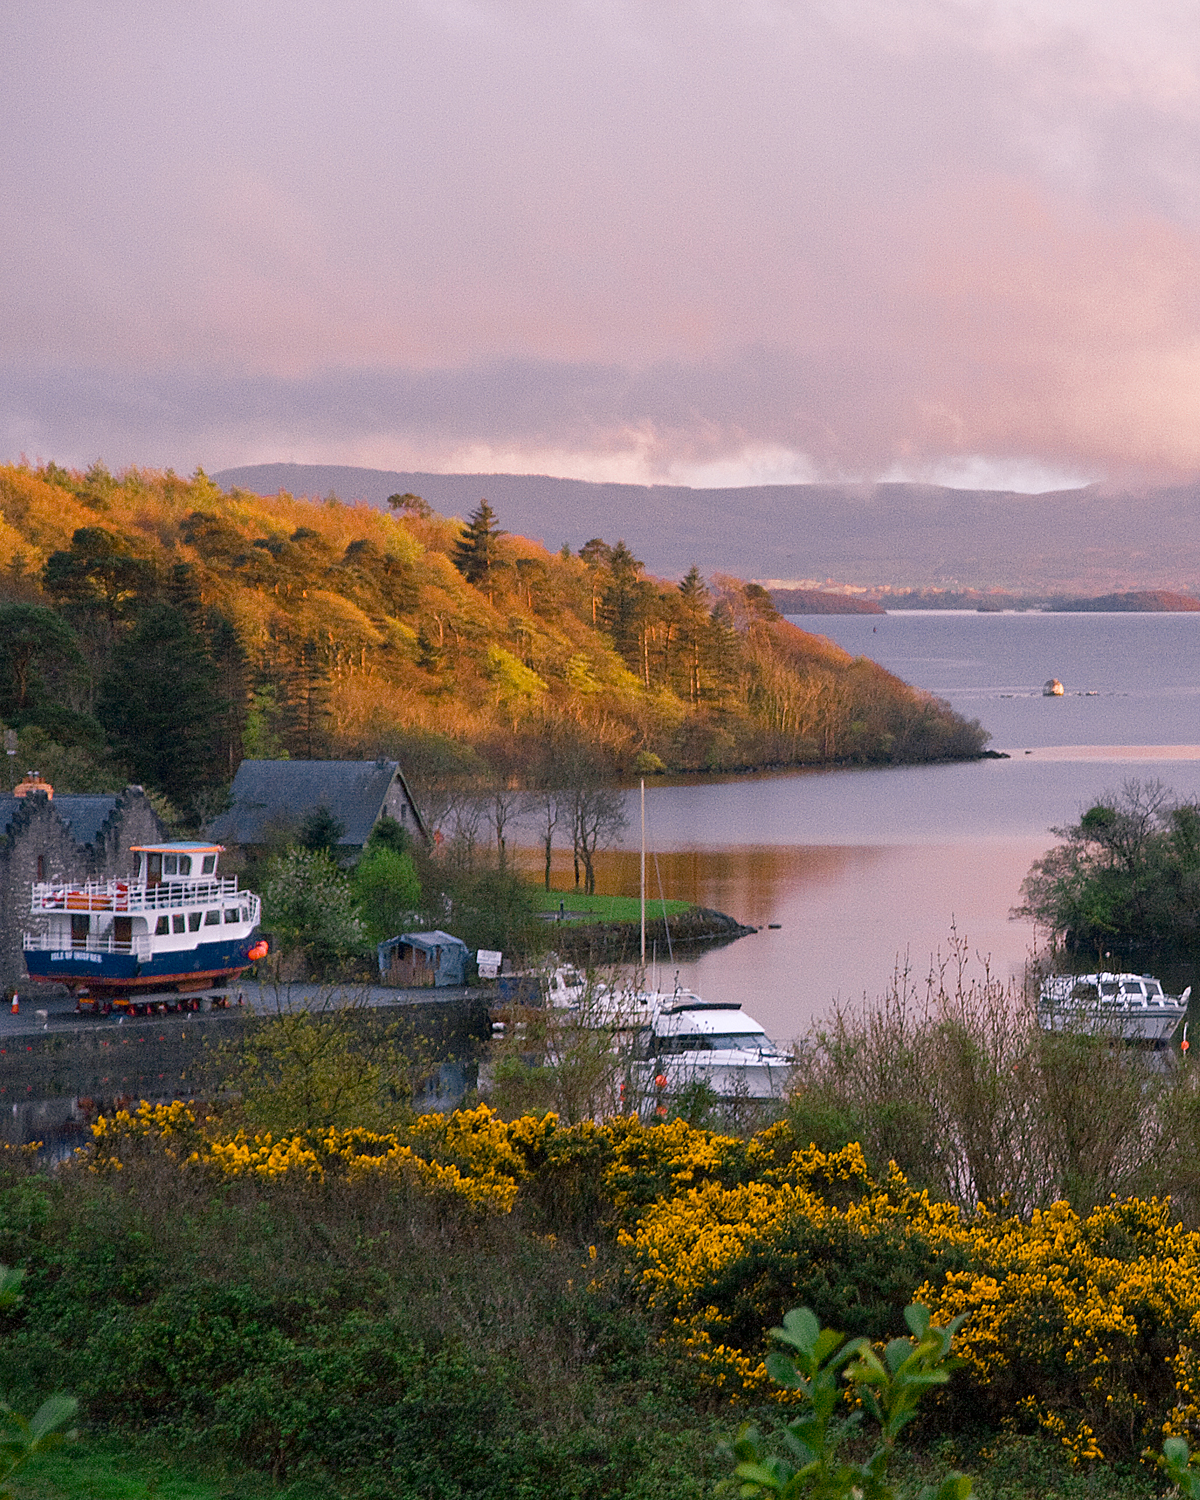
[24,842,267,1014]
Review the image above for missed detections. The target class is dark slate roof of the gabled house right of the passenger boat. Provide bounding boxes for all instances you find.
[209,761,423,849]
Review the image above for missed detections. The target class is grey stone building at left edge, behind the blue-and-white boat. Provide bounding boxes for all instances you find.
[0,771,168,992]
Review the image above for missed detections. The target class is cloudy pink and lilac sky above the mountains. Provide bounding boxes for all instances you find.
[0,0,1200,491]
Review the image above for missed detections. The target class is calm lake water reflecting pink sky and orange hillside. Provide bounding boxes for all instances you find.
[519,611,1200,1040]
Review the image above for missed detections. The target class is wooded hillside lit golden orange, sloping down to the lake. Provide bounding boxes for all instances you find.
[0,464,986,819]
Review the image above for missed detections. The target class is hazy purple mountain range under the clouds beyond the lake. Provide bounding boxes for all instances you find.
[212,464,1200,594]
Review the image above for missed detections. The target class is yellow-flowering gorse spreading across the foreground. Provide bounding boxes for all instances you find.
[89,1104,1200,1460]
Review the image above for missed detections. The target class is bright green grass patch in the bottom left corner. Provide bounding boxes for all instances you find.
[11,1437,278,1500]
